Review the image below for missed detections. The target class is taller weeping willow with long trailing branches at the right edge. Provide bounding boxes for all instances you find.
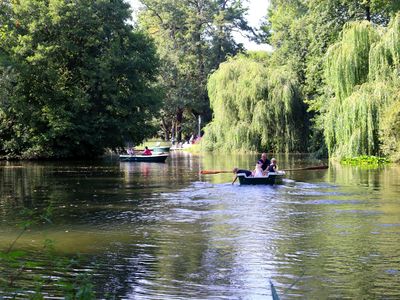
[324,16,400,157]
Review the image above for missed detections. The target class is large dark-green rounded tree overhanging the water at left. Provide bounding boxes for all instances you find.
[0,0,157,158]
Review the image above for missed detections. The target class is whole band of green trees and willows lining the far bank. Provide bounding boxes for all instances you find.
[0,0,400,164]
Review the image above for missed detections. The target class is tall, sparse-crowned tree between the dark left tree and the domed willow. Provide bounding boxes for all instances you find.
[139,0,251,139]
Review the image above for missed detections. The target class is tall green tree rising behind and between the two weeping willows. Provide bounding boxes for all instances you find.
[264,0,400,156]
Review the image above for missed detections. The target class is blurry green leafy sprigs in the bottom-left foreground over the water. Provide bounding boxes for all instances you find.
[0,204,95,299]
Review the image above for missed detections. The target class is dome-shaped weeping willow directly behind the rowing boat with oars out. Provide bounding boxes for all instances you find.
[203,51,306,152]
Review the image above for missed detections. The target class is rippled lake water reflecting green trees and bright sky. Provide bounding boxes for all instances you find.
[0,153,400,299]
